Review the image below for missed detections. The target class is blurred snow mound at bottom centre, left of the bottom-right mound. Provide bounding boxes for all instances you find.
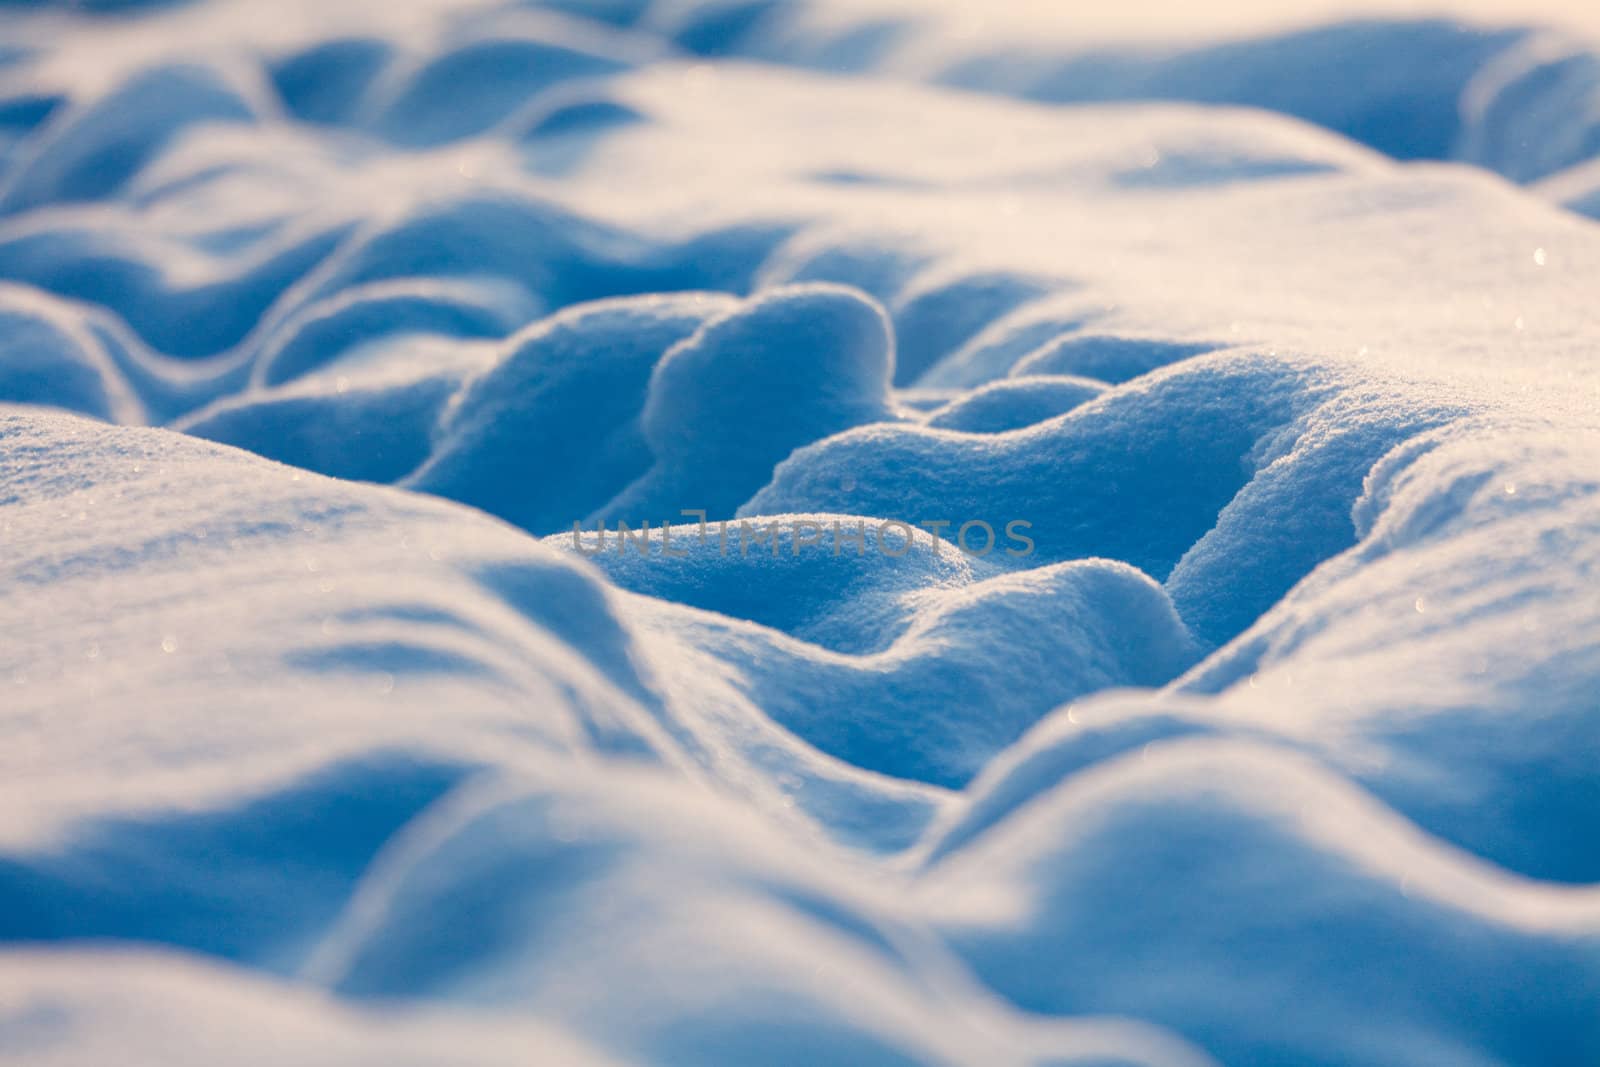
[300,767,1192,1065]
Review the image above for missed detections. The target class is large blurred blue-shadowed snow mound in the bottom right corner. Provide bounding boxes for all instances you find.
[920,741,1600,1064]
